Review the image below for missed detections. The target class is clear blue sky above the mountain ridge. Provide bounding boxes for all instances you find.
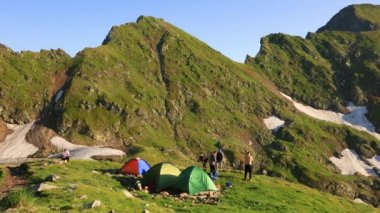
[0,0,380,62]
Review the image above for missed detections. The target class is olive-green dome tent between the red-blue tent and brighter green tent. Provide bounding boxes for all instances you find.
[141,163,181,192]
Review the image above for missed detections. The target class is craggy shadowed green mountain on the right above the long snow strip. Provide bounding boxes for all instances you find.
[246,5,380,130]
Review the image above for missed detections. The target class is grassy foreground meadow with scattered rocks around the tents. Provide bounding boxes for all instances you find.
[0,161,380,212]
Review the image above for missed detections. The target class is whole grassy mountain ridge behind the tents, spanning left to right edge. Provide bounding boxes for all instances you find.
[0,6,380,206]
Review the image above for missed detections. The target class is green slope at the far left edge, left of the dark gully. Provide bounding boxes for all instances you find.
[0,45,71,123]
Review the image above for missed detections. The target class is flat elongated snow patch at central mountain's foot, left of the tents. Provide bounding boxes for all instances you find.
[49,136,125,160]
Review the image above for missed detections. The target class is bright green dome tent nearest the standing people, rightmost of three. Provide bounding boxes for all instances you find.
[173,166,218,195]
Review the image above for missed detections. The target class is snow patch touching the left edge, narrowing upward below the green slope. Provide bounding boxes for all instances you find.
[0,122,38,163]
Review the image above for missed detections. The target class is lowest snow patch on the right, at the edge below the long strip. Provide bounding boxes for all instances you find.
[330,149,380,176]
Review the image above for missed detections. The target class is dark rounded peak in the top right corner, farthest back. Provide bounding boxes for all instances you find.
[317,4,380,32]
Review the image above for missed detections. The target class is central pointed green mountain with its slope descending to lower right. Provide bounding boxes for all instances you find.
[43,17,380,204]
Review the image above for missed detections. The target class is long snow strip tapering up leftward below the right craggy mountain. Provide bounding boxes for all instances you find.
[281,93,380,140]
